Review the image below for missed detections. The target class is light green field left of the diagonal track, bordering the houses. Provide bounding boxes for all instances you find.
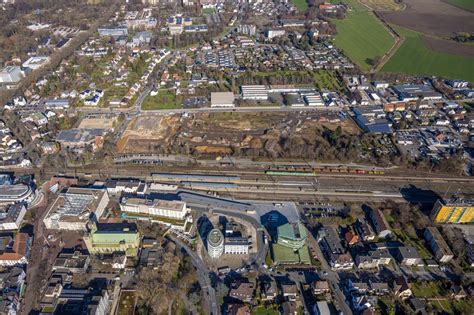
[333,7,395,71]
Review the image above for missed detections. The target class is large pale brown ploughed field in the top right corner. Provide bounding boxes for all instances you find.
[379,0,474,38]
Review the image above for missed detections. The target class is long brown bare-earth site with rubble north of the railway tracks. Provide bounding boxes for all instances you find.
[117,111,361,158]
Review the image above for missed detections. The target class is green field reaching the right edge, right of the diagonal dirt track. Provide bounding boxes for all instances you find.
[381,27,474,82]
